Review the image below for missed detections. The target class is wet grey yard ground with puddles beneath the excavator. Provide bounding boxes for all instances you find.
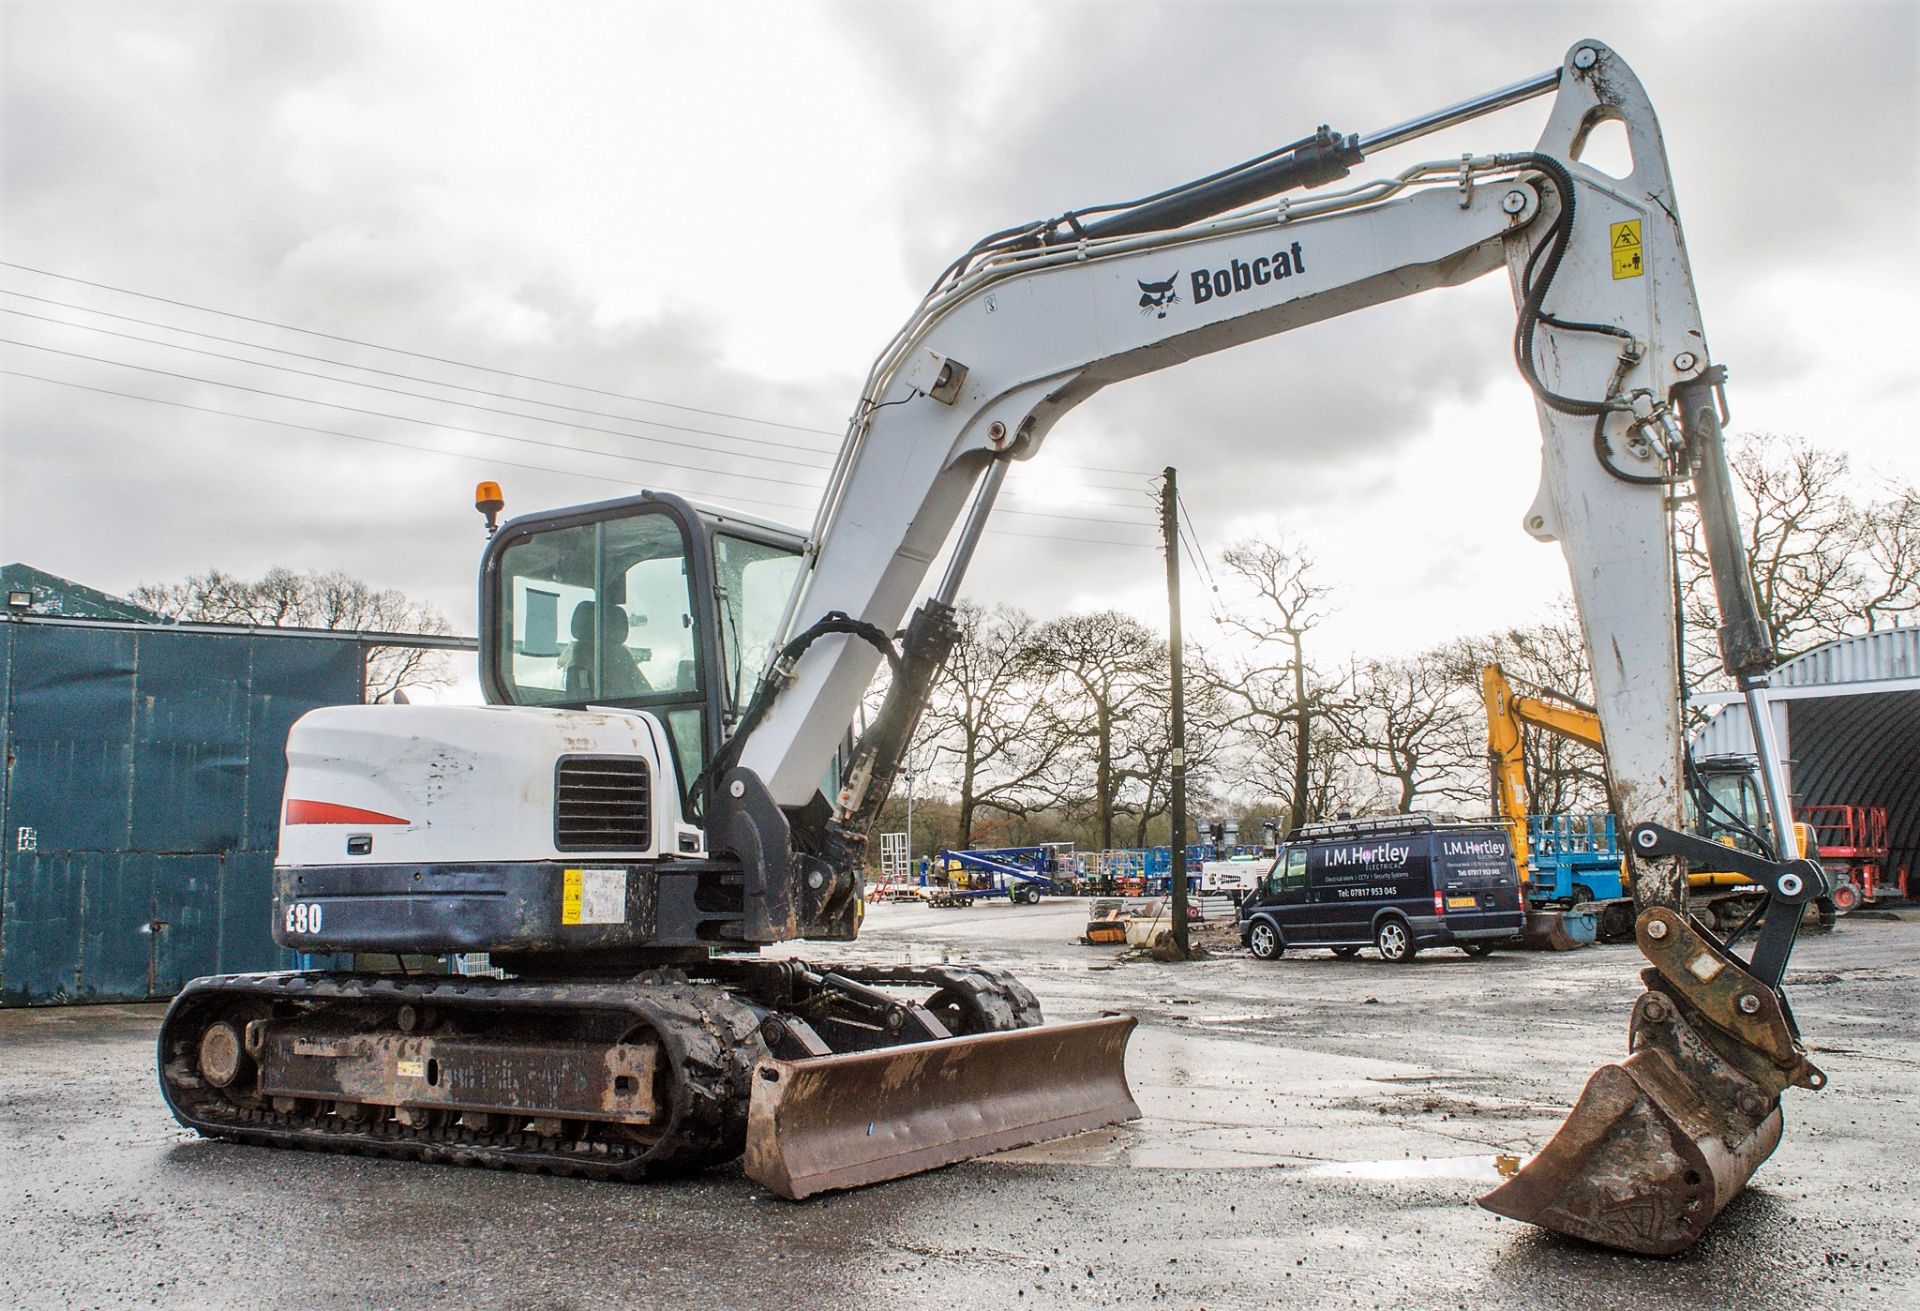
[0,900,1920,1311]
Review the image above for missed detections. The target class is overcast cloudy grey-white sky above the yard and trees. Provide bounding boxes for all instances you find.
[0,0,1920,698]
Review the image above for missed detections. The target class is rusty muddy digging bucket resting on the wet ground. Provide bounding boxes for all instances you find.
[1480,1048,1780,1255]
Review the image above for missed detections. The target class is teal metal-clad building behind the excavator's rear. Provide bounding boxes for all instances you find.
[0,616,363,1006]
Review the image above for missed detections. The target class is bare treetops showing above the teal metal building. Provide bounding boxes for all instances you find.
[132,566,453,701]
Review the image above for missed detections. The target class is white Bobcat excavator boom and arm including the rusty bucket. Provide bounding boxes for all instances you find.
[720,40,1797,1251]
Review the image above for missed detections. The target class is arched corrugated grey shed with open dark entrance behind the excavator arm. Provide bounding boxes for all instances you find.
[1693,628,1920,890]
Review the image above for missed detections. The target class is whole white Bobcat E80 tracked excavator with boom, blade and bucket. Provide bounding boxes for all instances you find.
[159,40,1822,1253]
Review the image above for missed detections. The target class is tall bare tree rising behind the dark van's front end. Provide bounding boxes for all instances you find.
[1208,537,1338,825]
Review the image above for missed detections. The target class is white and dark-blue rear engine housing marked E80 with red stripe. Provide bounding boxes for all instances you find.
[275,706,739,954]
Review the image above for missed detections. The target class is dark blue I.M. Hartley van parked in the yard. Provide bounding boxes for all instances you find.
[1240,814,1526,965]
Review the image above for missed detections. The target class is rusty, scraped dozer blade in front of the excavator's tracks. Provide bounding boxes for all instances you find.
[747,1015,1140,1200]
